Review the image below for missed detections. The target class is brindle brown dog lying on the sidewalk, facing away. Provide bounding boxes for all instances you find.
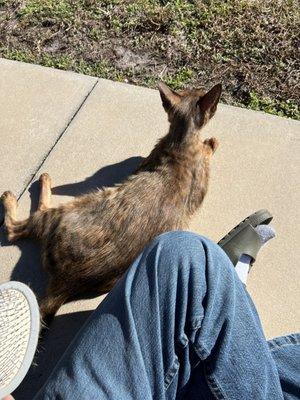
[2,83,221,322]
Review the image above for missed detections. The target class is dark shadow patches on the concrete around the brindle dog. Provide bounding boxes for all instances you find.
[0,156,143,400]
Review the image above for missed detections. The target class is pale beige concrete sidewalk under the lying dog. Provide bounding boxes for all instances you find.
[0,60,300,398]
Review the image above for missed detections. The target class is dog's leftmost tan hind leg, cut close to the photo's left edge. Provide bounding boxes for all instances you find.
[1,191,29,242]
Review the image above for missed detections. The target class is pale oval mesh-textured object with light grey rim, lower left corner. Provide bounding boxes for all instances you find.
[0,281,40,399]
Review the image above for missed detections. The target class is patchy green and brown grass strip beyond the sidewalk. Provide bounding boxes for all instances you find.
[0,0,300,119]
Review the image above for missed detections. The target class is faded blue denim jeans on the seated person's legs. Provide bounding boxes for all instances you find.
[35,232,300,400]
